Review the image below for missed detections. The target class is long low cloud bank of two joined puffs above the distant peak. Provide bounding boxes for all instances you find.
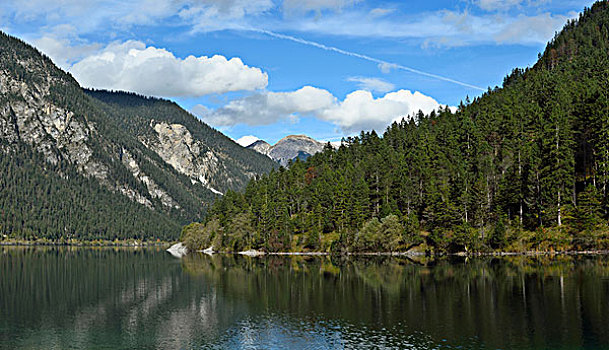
[197,86,440,133]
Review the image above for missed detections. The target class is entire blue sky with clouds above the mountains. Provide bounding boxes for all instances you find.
[0,0,593,144]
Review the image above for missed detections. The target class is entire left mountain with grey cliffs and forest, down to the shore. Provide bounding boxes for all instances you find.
[0,33,276,240]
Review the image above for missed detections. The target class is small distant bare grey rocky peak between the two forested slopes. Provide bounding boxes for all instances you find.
[247,135,325,167]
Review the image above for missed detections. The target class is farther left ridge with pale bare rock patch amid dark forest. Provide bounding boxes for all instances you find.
[85,90,276,192]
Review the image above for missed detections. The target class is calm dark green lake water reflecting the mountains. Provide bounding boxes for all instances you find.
[0,247,609,349]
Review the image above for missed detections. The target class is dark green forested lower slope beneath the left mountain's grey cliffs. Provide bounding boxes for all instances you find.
[0,145,180,242]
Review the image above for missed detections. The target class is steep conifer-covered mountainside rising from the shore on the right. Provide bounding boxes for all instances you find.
[182,1,609,252]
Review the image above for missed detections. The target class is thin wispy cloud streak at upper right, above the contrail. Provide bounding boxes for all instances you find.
[278,10,574,47]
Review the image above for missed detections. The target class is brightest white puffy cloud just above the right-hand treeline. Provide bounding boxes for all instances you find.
[318,90,440,132]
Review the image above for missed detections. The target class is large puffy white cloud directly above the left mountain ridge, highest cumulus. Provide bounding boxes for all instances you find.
[69,41,268,97]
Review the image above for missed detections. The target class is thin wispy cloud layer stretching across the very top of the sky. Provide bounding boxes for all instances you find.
[0,0,571,47]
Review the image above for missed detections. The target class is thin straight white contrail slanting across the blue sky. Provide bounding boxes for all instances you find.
[248,28,486,91]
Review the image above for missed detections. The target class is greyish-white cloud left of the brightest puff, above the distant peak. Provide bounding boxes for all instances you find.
[193,86,335,127]
